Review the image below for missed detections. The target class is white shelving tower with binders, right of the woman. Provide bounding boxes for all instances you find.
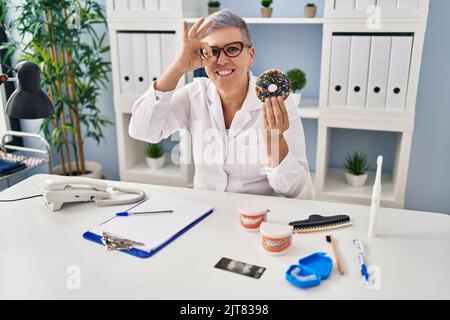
[315,0,428,208]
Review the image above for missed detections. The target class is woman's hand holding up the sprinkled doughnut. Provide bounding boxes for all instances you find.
[263,97,289,167]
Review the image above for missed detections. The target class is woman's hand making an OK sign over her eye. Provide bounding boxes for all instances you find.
[174,17,216,73]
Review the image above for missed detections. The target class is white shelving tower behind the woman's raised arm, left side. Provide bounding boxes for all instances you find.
[106,0,207,187]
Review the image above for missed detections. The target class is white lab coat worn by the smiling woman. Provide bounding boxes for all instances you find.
[129,72,309,197]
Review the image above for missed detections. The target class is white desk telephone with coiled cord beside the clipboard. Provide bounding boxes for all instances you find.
[34,175,145,211]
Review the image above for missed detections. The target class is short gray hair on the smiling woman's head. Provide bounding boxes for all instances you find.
[203,9,253,46]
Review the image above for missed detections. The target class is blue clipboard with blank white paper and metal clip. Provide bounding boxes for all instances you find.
[83,193,213,258]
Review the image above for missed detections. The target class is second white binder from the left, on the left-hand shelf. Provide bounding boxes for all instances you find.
[130,33,149,95]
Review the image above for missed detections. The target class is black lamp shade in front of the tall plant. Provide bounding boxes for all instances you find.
[6,61,55,119]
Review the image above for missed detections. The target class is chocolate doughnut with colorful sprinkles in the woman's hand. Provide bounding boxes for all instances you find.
[256,69,291,102]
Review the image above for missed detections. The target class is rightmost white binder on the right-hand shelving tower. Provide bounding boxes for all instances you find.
[386,36,413,110]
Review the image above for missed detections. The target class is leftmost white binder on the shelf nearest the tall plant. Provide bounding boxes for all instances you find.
[117,32,134,95]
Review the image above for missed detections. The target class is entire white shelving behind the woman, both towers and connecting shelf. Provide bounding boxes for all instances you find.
[107,0,428,208]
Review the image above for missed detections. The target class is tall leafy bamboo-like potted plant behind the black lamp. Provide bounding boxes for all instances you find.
[3,0,112,178]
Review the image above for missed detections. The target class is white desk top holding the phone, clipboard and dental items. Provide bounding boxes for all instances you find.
[0,177,450,299]
